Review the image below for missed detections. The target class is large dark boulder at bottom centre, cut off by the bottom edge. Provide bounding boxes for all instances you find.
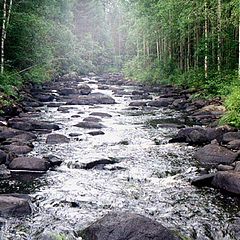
[80,213,179,240]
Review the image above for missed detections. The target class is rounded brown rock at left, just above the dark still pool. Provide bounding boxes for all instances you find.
[9,157,49,172]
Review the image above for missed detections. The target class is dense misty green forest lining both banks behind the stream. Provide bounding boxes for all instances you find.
[0,0,240,126]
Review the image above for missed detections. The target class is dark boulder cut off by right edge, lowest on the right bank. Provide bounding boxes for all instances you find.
[212,172,240,195]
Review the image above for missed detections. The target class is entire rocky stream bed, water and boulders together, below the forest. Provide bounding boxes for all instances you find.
[0,74,240,240]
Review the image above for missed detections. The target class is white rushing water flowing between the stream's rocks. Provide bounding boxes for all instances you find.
[0,78,240,240]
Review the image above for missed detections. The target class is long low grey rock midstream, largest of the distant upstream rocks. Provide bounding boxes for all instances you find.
[67,93,116,105]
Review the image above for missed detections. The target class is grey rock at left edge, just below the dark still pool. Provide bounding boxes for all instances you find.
[0,194,32,217]
